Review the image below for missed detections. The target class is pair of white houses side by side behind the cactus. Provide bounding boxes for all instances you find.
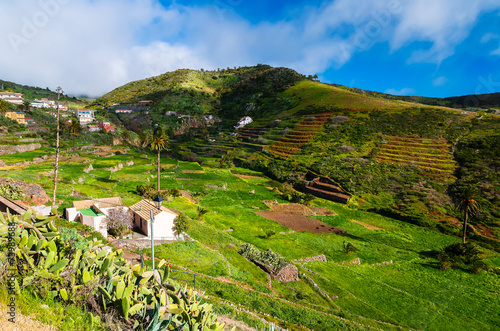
[65,197,178,240]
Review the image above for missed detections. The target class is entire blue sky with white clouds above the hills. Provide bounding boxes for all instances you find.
[0,0,500,97]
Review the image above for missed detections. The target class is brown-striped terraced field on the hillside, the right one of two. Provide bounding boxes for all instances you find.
[377,136,456,177]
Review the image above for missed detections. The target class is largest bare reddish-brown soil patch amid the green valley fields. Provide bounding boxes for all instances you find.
[255,211,347,234]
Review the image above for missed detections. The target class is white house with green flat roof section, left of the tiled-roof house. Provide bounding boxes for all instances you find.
[66,197,127,238]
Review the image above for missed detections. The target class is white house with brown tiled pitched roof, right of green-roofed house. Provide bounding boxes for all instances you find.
[130,199,178,240]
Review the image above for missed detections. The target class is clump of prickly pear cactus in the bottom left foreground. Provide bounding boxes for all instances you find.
[0,212,229,331]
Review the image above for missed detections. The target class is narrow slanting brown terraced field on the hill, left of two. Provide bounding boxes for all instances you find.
[266,113,332,158]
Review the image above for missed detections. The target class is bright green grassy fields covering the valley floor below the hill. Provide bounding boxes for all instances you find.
[0,147,500,331]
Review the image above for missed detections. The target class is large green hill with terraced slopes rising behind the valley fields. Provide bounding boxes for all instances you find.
[91,65,500,230]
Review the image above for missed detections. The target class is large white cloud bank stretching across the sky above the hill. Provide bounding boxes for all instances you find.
[0,0,500,96]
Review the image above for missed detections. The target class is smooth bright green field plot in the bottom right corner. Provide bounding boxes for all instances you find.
[307,260,500,330]
